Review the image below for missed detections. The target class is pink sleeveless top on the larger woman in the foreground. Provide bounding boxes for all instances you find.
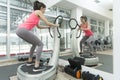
[18,12,40,30]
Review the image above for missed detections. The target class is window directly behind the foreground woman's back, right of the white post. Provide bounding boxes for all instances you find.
[10,9,30,54]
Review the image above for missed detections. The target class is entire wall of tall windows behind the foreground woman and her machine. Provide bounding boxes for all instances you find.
[0,0,70,55]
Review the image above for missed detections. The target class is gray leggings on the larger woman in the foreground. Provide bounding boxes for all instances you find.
[16,28,43,61]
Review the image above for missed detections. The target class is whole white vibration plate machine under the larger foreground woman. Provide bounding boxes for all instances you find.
[17,15,63,80]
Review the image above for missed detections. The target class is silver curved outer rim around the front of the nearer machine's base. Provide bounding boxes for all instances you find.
[17,64,57,80]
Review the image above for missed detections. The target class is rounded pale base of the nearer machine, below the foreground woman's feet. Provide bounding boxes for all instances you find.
[17,64,56,80]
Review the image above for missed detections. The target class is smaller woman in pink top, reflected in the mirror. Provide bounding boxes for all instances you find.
[78,16,93,54]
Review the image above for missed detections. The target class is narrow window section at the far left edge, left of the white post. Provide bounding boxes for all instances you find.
[0,6,7,55]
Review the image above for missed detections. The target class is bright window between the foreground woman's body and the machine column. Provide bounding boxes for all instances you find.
[37,16,55,50]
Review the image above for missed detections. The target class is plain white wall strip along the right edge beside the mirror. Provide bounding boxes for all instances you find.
[113,0,120,80]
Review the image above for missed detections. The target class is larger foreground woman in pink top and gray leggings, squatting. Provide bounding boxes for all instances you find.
[16,1,59,71]
